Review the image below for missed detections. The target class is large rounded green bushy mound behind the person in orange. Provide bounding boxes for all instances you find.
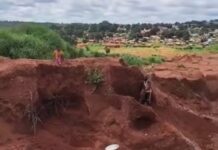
[0,24,77,59]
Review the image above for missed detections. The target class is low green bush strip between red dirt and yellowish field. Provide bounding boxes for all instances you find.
[121,55,164,66]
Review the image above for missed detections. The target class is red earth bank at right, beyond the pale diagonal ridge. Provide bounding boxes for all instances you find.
[152,55,218,150]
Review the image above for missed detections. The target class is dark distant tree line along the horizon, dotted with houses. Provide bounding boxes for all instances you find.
[0,20,218,44]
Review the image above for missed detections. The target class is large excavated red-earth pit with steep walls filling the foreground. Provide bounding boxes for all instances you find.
[0,56,218,150]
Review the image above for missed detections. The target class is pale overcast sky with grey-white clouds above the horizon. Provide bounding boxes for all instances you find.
[0,0,218,23]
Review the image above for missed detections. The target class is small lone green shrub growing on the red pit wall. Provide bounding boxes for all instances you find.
[87,69,104,87]
